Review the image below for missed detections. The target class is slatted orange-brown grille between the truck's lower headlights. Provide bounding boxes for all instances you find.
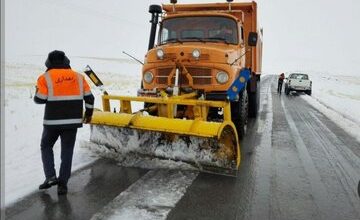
[156,67,212,86]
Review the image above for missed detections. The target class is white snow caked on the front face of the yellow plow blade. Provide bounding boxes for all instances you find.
[84,126,231,169]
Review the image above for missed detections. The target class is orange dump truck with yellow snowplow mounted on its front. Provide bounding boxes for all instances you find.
[86,1,262,175]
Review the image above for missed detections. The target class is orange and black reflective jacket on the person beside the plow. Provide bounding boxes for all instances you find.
[34,69,94,128]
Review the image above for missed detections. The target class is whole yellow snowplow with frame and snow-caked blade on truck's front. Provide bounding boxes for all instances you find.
[90,95,240,176]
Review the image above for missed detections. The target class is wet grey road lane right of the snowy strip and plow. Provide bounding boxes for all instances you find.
[168,76,360,220]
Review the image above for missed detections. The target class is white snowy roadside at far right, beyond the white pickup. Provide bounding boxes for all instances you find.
[301,73,360,142]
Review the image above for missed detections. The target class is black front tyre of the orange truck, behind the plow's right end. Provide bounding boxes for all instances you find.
[231,89,249,139]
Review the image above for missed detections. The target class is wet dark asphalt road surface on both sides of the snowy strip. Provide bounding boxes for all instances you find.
[6,76,360,220]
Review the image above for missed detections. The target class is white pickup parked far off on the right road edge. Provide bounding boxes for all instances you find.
[285,73,312,95]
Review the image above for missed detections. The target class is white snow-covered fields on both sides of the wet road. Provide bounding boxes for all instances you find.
[5,56,360,205]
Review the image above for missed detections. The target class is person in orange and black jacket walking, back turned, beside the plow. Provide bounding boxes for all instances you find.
[34,50,94,195]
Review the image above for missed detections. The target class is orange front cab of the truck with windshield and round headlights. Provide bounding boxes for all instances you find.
[143,13,245,93]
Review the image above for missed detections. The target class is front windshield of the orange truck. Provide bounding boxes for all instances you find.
[159,16,239,44]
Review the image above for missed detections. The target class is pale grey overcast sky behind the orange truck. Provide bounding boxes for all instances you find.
[5,0,360,75]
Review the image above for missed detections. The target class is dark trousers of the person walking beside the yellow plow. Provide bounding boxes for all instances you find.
[40,126,77,185]
